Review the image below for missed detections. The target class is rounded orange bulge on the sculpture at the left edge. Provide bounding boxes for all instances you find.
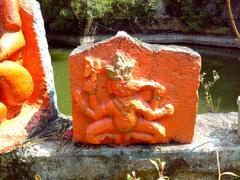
[0,61,34,106]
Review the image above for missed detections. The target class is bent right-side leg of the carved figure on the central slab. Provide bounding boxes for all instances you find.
[127,119,165,143]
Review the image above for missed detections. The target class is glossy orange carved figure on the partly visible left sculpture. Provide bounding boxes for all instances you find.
[0,0,34,123]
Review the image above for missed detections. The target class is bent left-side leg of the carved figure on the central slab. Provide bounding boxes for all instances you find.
[86,118,120,144]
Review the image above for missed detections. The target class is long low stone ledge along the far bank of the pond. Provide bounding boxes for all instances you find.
[47,33,240,48]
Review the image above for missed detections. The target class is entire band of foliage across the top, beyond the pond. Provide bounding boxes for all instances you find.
[39,0,229,34]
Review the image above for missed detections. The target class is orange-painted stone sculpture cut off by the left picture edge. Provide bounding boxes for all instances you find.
[0,0,57,153]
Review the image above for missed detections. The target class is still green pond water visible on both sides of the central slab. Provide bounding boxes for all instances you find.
[50,48,240,115]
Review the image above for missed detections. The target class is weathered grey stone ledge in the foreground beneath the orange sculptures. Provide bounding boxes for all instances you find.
[0,112,240,179]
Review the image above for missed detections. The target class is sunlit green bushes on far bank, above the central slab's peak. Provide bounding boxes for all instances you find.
[39,0,158,34]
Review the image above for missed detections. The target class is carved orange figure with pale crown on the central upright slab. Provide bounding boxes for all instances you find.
[73,51,174,144]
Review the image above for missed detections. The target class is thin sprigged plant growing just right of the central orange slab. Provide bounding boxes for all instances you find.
[200,70,220,112]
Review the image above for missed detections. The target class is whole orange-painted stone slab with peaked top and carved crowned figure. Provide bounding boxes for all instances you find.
[69,32,201,144]
